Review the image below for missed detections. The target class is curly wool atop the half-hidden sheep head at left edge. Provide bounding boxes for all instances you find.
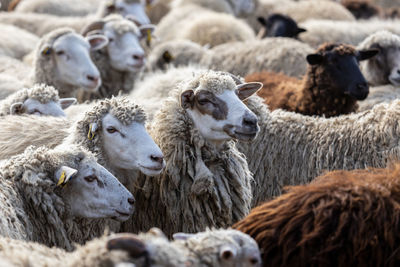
[0,84,60,116]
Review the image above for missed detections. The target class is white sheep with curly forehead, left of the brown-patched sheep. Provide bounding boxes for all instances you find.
[0,97,165,184]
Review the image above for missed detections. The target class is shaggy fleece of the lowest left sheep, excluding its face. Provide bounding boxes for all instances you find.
[0,146,96,250]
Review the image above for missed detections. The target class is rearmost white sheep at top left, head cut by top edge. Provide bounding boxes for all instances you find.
[0,0,150,36]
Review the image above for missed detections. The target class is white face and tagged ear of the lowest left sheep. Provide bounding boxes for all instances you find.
[56,155,135,221]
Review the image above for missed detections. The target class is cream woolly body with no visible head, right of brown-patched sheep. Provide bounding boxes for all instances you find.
[237,97,400,207]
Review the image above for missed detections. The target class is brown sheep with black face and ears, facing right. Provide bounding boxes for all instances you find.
[246,43,378,117]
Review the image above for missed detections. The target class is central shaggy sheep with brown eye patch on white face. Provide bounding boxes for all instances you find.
[122,71,261,236]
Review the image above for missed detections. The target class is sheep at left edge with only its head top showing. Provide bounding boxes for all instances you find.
[0,84,76,116]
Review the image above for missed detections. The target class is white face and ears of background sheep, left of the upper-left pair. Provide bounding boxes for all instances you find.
[48,33,107,91]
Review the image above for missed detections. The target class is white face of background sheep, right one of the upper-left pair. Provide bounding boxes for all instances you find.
[104,21,145,73]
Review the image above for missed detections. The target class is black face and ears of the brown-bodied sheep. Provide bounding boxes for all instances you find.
[307,46,378,100]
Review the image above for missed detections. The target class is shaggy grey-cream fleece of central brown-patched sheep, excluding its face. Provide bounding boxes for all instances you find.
[123,72,252,236]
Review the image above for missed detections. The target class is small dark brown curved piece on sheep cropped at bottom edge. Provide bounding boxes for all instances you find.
[106,234,148,260]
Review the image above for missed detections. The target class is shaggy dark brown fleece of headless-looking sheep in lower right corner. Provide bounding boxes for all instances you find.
[233,163,400,267]
